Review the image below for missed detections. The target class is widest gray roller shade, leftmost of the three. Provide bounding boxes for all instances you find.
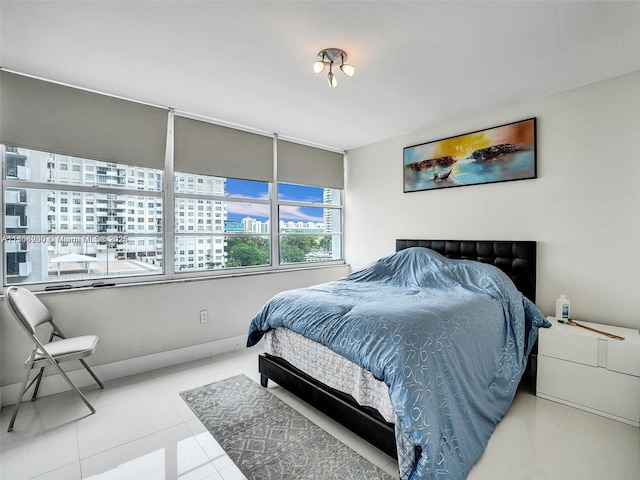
[0,71,168,169]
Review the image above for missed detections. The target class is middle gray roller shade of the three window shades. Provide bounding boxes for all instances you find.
[174,115,273,182]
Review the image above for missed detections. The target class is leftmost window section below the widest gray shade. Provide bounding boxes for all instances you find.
[4,146,163,284]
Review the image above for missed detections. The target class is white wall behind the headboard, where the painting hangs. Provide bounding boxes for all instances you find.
[345,72,640,329]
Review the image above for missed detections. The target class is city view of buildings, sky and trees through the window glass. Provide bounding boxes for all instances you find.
[3,142,343,284]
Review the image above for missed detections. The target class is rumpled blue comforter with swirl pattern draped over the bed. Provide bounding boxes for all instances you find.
[247,247,550,480]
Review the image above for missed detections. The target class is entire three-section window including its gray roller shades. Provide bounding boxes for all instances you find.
[0,71,344,289]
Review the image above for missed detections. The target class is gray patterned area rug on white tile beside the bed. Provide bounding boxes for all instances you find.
[180,375,393,480]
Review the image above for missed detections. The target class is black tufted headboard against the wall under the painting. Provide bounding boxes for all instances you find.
[396,240,536,303]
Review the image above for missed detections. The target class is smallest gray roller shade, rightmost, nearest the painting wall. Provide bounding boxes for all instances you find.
[278,140,344,189]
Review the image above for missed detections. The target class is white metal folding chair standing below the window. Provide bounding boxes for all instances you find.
[5,287,104,432]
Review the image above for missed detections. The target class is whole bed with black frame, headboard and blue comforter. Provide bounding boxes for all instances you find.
[247,240,548,480]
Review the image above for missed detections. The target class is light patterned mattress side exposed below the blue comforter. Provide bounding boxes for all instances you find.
[264,328,396,423]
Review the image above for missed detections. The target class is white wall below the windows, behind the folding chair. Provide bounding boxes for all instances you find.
[0,265,349,388]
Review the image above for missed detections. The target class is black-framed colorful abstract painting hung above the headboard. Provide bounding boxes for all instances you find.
[402,117,537,193]
